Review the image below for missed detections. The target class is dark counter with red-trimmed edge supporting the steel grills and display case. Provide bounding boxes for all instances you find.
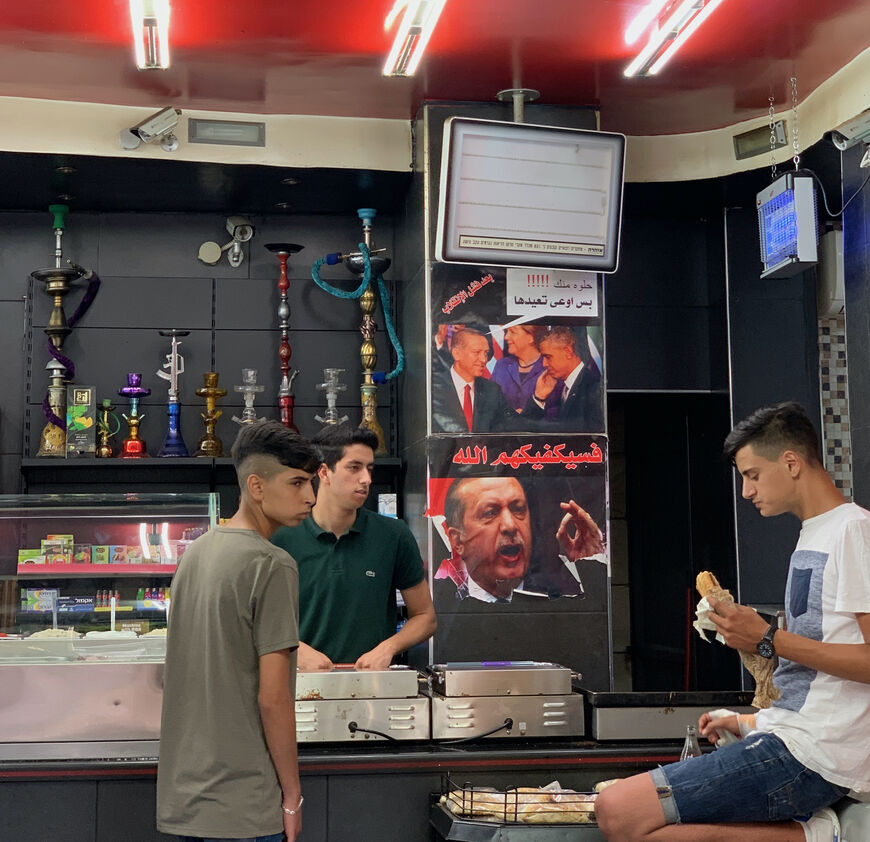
[0,740,681,842]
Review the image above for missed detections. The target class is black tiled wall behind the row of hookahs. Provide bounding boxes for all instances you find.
[0,212,396,488]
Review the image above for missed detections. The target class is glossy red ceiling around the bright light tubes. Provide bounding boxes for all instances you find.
[0,0,870,135]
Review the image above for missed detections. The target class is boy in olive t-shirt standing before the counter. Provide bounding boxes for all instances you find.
[157,421,320,842]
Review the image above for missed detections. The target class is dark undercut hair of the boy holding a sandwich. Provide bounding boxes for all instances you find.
[723,401,822,465]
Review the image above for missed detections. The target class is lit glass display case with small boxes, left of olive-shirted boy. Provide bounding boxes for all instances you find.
[0,493,218,760]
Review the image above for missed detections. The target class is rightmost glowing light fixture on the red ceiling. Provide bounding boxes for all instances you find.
[623,0,722,76]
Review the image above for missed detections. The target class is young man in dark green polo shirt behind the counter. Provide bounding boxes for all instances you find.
[272,425,436,670]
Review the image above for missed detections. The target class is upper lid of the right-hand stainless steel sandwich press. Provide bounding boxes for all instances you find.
[429,661,572,697]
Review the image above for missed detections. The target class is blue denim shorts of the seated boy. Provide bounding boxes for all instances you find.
[650,733,849,824]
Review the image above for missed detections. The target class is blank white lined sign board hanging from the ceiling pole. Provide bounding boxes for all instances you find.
[436,117,625,272]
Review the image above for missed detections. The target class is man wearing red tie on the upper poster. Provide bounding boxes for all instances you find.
[432,326,521,433]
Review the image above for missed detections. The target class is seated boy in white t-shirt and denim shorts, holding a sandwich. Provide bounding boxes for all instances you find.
[595,403,870,842]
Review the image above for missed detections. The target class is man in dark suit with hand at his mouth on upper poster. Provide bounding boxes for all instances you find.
[522,326,604,433]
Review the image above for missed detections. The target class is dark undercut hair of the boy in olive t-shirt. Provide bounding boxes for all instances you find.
[230,421,321,492]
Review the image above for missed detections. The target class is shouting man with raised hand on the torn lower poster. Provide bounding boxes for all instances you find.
[435,477,606,607]
